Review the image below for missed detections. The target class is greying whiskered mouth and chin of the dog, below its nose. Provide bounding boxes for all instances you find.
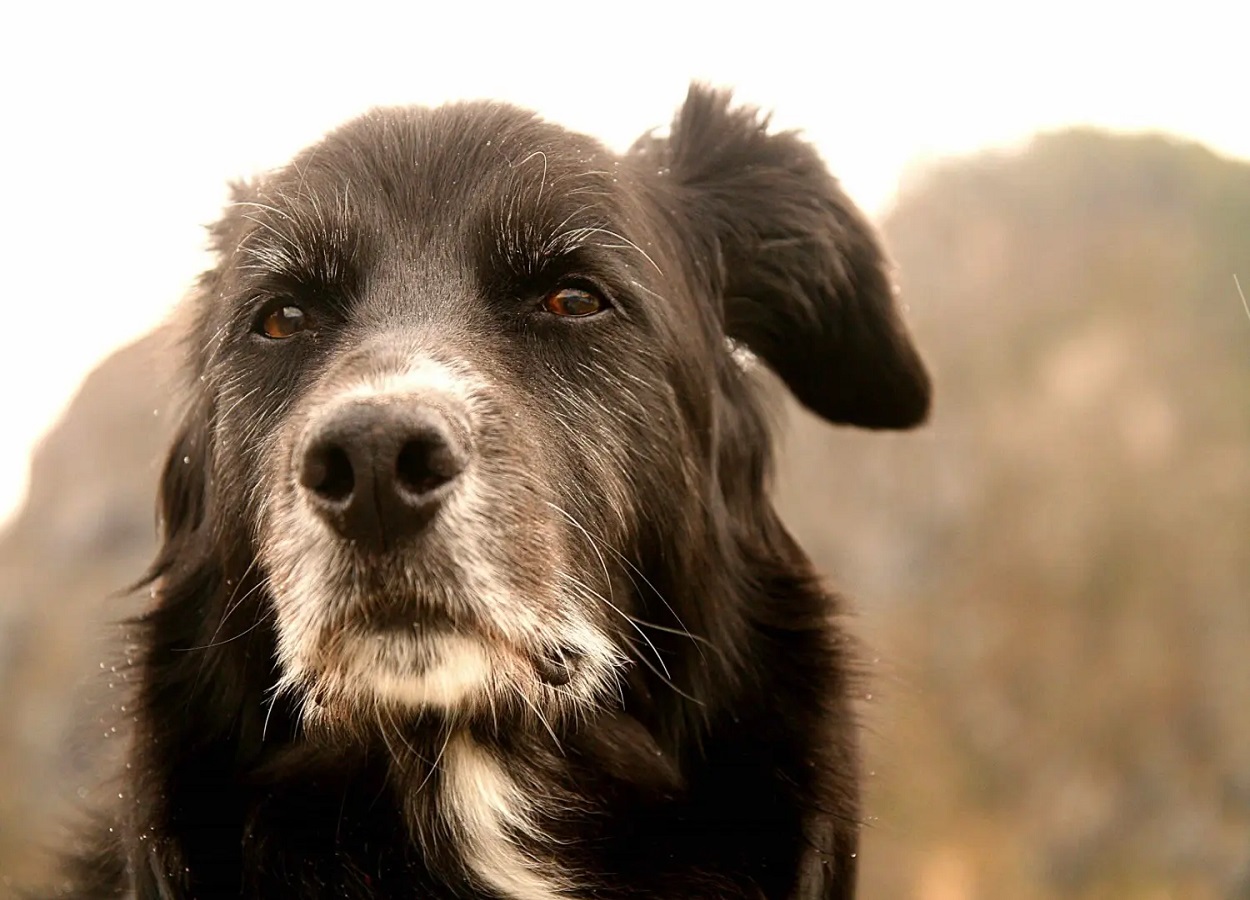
[265,470,626,726]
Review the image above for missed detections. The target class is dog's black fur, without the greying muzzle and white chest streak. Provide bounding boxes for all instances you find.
[46,88,929,900]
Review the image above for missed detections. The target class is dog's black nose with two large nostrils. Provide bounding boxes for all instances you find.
[300,401,468,549]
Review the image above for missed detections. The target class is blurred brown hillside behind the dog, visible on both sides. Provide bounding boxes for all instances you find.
[0,131,1250,900]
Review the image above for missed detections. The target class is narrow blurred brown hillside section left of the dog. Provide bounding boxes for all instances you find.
[0,336,171,898]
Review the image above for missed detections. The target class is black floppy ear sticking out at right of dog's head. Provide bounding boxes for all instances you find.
[631,85,930,429]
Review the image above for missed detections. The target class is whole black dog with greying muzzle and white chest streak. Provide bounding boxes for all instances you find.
[46,84,930,900]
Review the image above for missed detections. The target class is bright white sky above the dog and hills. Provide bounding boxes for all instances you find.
[0,0,1250,520]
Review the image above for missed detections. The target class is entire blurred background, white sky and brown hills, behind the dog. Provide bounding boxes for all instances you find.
[0,0,1250,900]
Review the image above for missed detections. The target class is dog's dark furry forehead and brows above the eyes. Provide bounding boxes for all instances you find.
[218,103,640,316]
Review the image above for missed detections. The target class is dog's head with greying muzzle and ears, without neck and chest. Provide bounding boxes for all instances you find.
[158,89,929,740]
